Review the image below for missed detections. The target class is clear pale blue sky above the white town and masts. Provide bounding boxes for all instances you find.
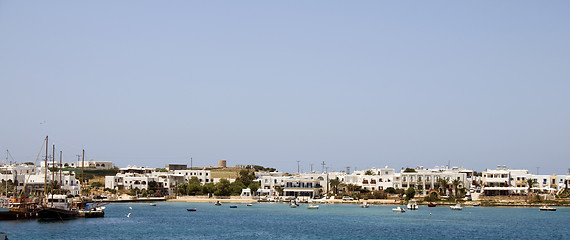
[0,0,570,174]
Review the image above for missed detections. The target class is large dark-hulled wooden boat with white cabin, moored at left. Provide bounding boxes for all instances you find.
[38,194,79,221]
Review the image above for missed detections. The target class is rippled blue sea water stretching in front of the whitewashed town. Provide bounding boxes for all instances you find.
[0,202,570,240]
